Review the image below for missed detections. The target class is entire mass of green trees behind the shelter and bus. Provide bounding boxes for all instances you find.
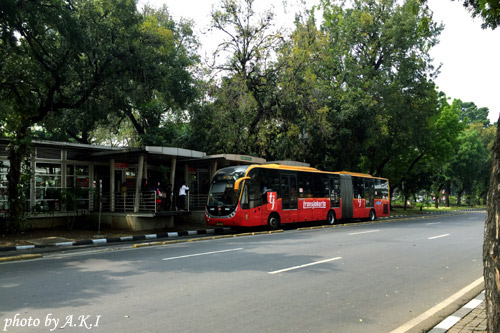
[0,0,495,231]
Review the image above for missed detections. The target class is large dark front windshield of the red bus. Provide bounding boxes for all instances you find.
[207,166,248,206]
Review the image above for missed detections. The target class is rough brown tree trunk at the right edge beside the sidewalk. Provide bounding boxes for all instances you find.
[483,118,500,332]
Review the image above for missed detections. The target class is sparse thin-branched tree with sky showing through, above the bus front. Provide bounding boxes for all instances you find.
[199,0,282,156]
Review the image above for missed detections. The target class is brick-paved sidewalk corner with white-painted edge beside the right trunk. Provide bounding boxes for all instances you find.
[429,291,486,333]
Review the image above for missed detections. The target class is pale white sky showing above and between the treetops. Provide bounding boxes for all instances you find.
[139,0,500,123]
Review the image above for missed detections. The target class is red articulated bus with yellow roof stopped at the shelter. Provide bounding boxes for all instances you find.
[205,164,389,229]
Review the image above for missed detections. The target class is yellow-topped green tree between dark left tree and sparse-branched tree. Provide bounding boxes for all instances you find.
[116,6,198,145]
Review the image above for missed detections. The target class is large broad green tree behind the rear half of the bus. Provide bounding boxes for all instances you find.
[318,0,442,179]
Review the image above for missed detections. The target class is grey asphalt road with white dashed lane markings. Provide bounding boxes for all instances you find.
[0,213,485,333]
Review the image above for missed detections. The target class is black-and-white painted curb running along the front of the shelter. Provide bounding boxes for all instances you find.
[0,227,232,253]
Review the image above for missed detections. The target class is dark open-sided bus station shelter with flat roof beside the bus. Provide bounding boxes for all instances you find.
[0,139,266,230]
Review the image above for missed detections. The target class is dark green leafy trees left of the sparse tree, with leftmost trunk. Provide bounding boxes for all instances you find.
[0,0,197,228]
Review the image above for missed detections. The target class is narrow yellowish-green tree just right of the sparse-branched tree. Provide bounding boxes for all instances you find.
[264,8,334,163]
